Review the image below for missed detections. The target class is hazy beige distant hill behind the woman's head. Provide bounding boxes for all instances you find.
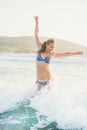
[0,36,87,54]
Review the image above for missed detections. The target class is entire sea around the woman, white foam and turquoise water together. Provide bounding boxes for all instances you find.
[0,53,87,130]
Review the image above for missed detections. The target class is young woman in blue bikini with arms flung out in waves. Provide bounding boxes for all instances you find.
[34,16,82,89]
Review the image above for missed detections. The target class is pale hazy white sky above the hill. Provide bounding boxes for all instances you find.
[0,0,87,46]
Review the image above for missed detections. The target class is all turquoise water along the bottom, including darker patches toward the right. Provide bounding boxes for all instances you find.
[0,102,57,130]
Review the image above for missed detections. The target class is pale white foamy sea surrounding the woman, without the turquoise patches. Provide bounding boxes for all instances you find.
[0,54,87,130]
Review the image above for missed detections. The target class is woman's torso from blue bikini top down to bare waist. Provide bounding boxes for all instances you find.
[36,53,51,81]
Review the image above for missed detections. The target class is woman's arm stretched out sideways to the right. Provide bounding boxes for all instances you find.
[54,52,83,57]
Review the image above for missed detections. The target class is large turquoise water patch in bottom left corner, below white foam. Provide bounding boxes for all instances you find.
[0,104,37,130]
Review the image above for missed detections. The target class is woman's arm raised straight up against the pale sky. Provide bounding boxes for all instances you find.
[34,16,42,49]
